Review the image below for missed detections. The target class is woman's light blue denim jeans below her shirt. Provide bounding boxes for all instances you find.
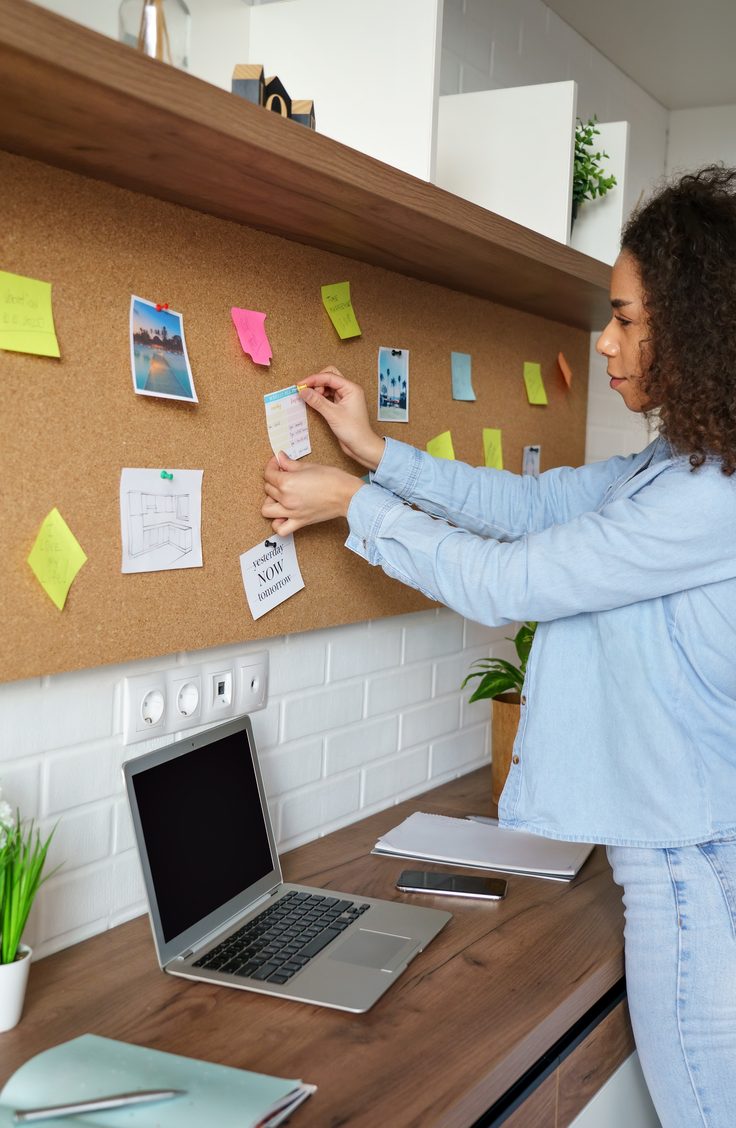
[607,839,736,1128]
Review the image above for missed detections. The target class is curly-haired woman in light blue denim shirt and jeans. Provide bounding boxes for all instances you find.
[263,167,736,1128]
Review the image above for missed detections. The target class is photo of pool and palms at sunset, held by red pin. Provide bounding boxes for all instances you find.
[130,294,199,403]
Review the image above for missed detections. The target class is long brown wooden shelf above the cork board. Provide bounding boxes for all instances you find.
[0,0,610,329]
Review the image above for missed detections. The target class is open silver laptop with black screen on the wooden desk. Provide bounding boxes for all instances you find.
[123,716,452,1013]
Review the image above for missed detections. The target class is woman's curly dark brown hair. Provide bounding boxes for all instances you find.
[621,165,736,475]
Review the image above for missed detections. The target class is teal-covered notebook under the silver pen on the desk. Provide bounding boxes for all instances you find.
[0,1034,314,1128]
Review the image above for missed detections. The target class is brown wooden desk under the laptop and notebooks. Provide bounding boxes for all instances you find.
[0,768,630,1128]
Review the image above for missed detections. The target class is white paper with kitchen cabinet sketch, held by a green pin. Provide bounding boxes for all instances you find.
[120,467,203,573]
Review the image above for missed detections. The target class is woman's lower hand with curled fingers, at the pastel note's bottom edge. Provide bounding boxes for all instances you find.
[261,451,363,537]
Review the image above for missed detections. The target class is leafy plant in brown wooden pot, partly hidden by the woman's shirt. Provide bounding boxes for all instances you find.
[462,623,536,804]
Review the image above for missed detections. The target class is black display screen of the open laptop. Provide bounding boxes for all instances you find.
[131,726,277,942]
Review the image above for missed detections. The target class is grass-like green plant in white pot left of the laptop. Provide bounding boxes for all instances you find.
[0,800,53,1031]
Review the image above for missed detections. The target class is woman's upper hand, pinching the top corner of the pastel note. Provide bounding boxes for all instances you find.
[299,365,385,470]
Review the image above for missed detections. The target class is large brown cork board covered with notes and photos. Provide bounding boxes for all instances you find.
[0,153,588,680]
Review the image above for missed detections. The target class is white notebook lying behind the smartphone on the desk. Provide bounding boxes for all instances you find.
[373,811,593,881]
